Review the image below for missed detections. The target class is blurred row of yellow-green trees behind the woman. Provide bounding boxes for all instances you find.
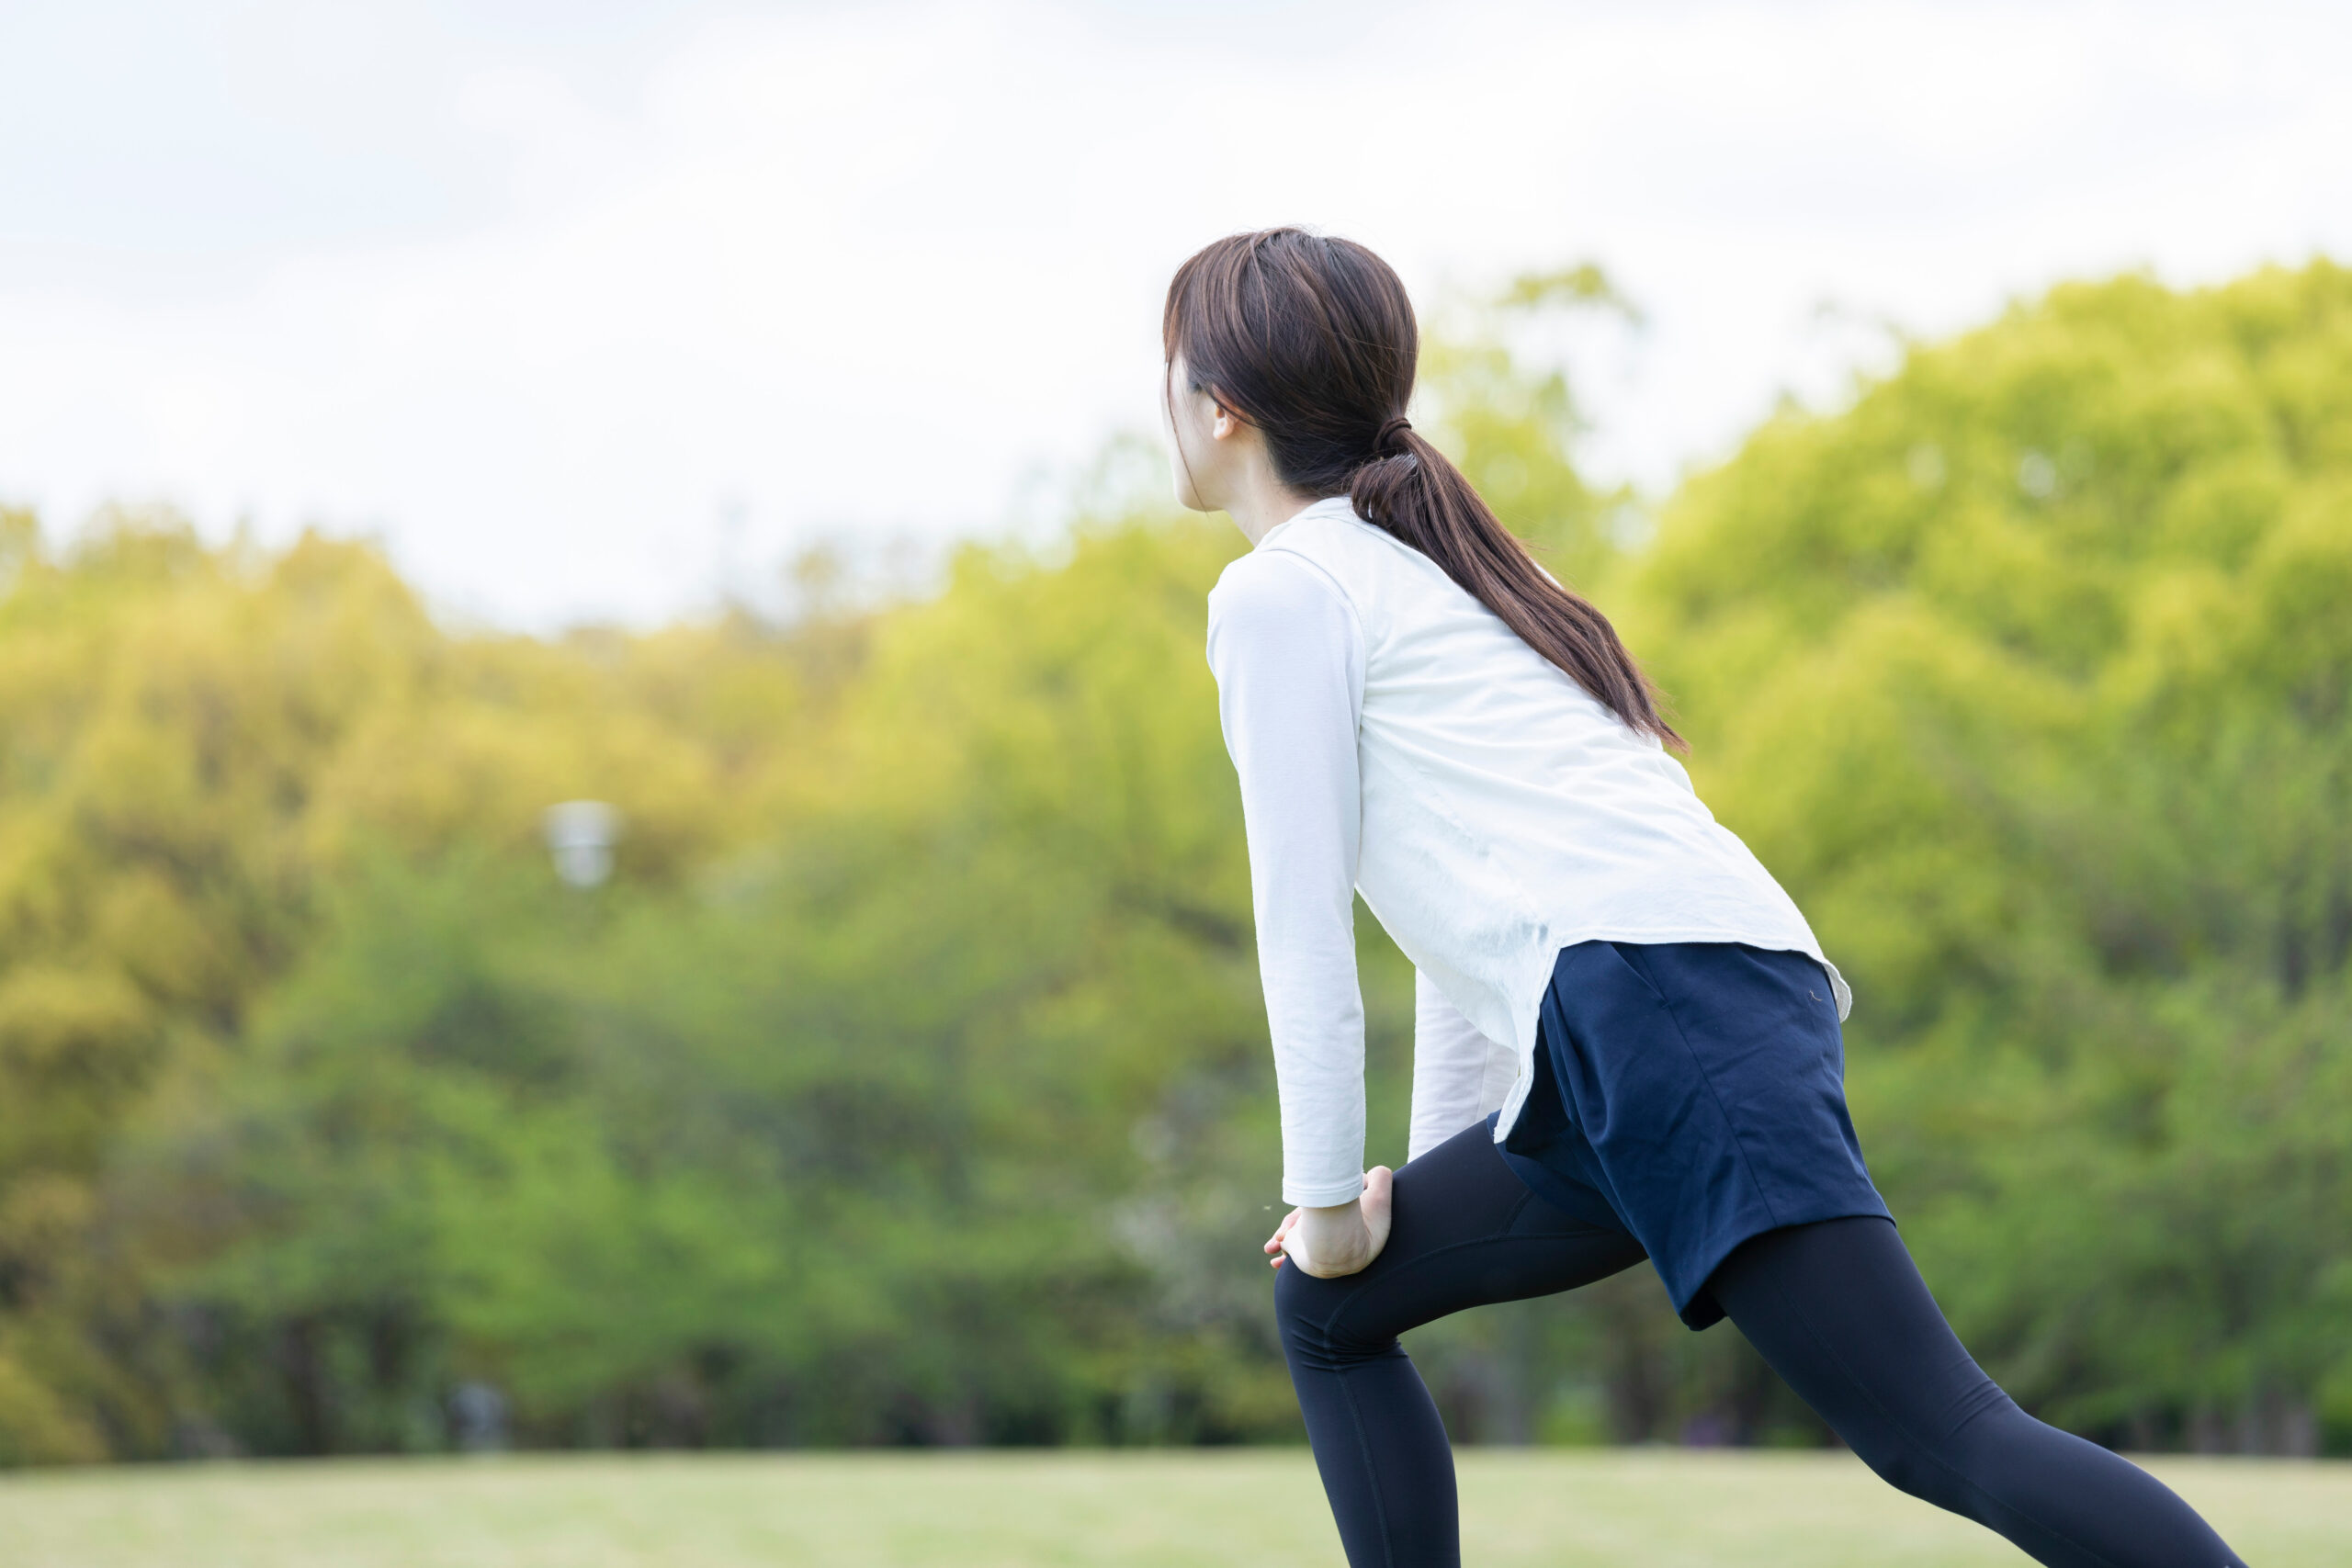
[0,264,2352,1462]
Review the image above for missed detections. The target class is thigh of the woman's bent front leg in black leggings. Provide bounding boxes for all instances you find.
[1275,1123,1646,1354]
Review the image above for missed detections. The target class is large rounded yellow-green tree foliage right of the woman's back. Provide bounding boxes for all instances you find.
[1625,264,2352,1448]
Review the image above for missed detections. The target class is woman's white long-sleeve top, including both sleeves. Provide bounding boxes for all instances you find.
[1209,496,1851,1206]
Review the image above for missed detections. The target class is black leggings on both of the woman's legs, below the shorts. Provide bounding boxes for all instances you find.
[1275,1126,2244,1568]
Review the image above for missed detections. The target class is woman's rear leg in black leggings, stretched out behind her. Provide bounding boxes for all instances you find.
[1708,1218,2244,1568]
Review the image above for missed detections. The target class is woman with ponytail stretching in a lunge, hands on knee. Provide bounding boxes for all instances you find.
[1164,228,2239,1568]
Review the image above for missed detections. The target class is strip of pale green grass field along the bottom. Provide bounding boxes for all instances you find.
[0,1450,2352,1568]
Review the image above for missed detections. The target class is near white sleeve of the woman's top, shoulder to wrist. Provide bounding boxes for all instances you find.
[1209,550,1364,1208]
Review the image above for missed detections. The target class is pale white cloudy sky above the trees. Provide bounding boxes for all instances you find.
[0,0,2352,627]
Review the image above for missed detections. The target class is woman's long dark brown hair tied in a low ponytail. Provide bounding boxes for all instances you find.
[1159,228,1681,748]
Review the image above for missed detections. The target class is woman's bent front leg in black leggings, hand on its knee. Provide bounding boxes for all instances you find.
[1275,1123,1644,1568]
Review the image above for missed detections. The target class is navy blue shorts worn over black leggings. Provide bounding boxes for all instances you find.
[1503,942,1894,1328]
